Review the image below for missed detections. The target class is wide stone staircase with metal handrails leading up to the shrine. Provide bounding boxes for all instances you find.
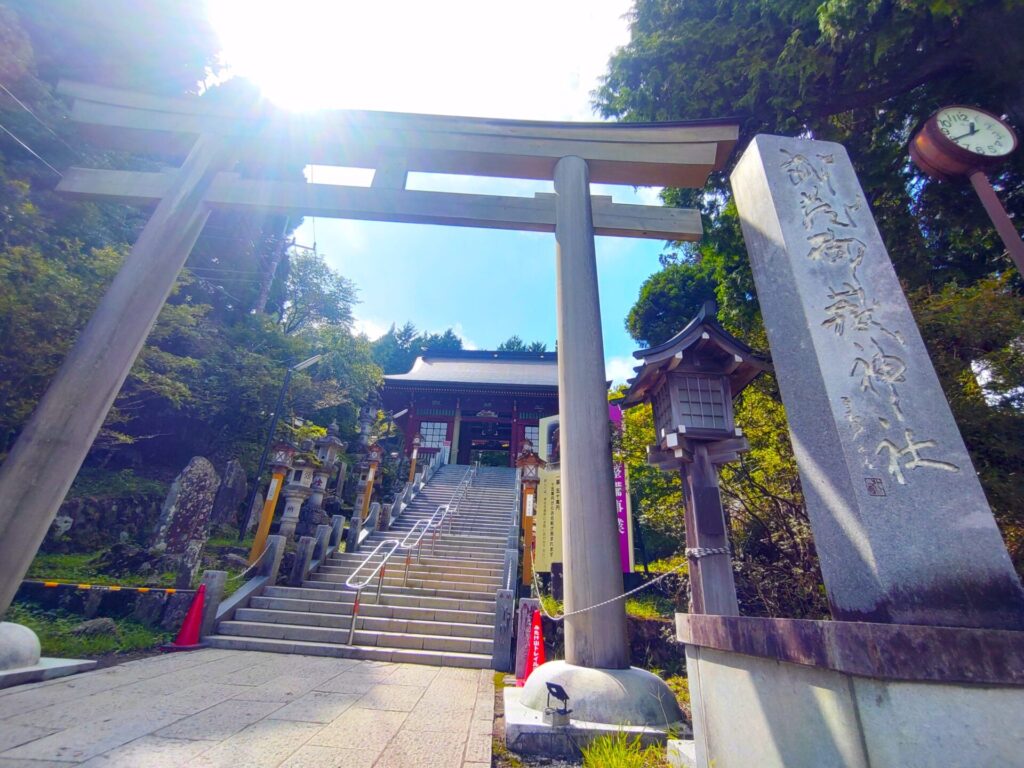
[207,465,515,669]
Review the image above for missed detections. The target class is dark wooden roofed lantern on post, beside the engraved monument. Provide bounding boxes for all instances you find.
[622,301,770,615]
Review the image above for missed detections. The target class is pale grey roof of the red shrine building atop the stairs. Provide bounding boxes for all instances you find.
[384,349,558,389]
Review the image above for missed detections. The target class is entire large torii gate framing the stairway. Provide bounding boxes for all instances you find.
[0,83,737,669]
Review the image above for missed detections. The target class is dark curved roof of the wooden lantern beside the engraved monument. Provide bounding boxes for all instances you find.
[622,301,771,408]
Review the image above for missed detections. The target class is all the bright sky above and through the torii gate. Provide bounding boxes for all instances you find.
[207,0,664,381]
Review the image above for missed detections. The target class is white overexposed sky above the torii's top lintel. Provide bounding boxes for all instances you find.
[207,0,629,120]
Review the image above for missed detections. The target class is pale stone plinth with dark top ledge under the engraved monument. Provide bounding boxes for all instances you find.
[677,614,1024,768]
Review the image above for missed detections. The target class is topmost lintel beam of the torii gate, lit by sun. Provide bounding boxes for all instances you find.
[58,81,738,186]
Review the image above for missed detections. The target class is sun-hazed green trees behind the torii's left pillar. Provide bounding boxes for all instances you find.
[0,0,381,494]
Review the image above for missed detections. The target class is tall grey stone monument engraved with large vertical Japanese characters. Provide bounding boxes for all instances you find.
[732,135,1024,630]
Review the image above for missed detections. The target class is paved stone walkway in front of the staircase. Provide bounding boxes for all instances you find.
[0,649,494,768]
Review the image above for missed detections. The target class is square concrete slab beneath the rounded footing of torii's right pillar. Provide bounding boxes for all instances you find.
[505,688,688,760]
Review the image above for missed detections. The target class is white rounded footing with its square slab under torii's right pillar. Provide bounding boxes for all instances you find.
[505,662,689,758]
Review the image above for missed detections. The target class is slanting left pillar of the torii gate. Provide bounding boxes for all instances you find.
[0,135,238,613]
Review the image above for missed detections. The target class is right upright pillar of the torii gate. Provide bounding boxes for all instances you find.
[555,157,630,669]
